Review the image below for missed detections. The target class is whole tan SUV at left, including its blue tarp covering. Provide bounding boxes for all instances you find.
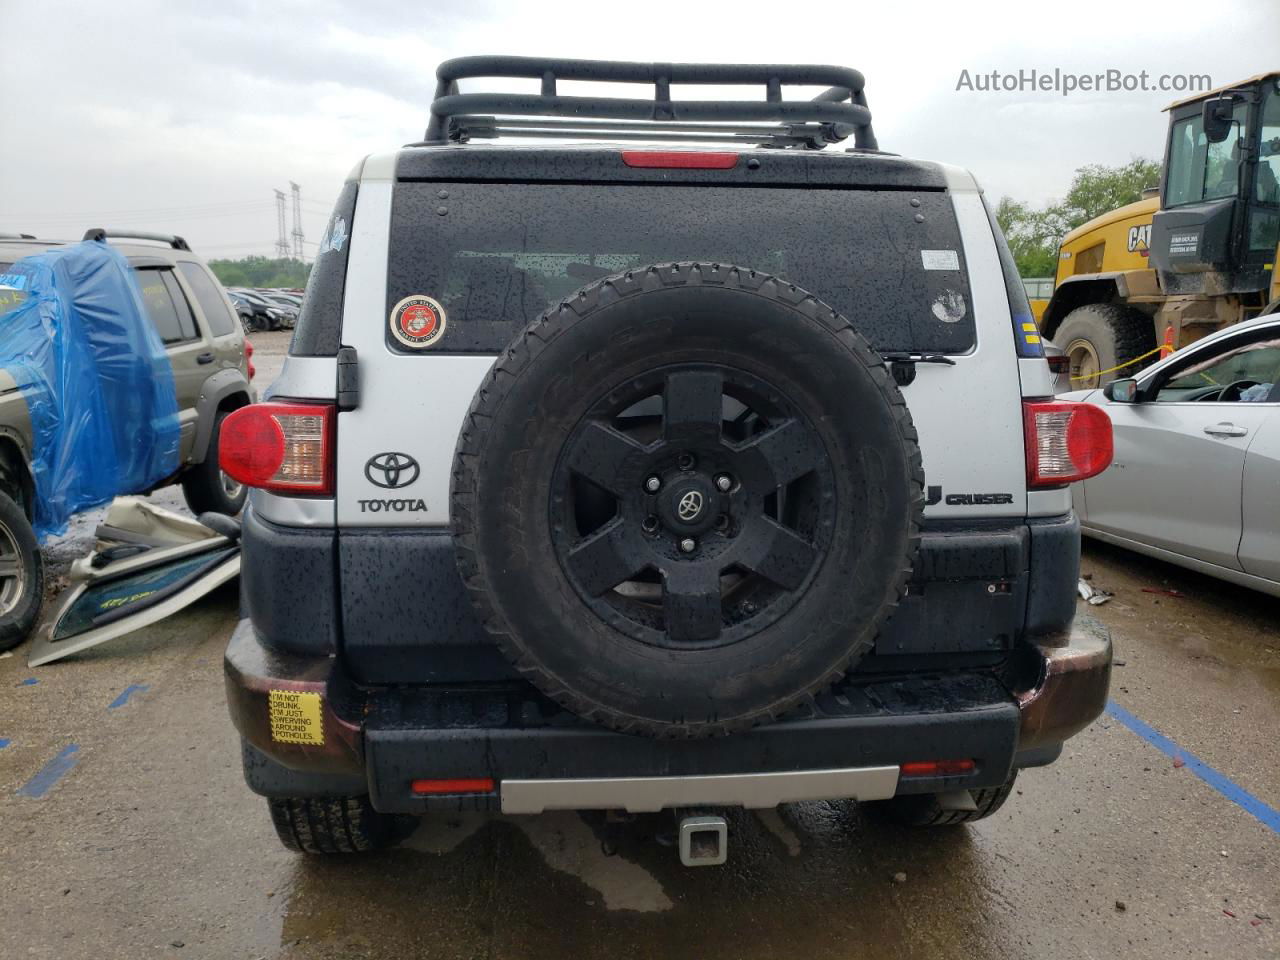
[0,229,256,648]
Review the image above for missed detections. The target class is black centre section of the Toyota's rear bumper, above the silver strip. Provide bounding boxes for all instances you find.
[365,673,1019,813]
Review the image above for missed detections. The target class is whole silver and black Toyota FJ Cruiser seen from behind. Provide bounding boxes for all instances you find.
[221,58,1111,863]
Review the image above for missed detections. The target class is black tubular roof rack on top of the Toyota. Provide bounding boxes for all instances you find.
[424,56,877,150]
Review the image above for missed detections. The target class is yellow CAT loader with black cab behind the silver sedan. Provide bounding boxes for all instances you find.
[1041,72,1280,389]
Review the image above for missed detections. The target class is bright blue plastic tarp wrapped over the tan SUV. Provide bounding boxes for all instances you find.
[0,241,179,538]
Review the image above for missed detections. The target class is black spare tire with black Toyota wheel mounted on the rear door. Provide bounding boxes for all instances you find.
[451,264,923,737]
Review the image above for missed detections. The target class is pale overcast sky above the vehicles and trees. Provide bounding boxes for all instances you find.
[0,0,1280,259]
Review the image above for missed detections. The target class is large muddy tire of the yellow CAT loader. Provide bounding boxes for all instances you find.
[1053,303,1156,390]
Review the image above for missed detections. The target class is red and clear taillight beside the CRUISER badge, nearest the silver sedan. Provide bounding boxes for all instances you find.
[1023,402,1114,488]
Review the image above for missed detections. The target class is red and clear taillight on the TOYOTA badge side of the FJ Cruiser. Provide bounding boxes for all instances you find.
[218,402,334,495]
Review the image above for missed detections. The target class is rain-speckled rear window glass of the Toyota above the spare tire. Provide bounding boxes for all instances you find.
[387,183,974,353]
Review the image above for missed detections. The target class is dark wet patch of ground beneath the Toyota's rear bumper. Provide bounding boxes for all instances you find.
[280,803,1025,960]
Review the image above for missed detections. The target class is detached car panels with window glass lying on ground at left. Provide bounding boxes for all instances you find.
[27,504,241,667]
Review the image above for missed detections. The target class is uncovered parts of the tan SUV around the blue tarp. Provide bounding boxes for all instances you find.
[0,229,256,649]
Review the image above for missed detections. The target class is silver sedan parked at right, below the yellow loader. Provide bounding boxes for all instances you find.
[1060,315,1280,596]
